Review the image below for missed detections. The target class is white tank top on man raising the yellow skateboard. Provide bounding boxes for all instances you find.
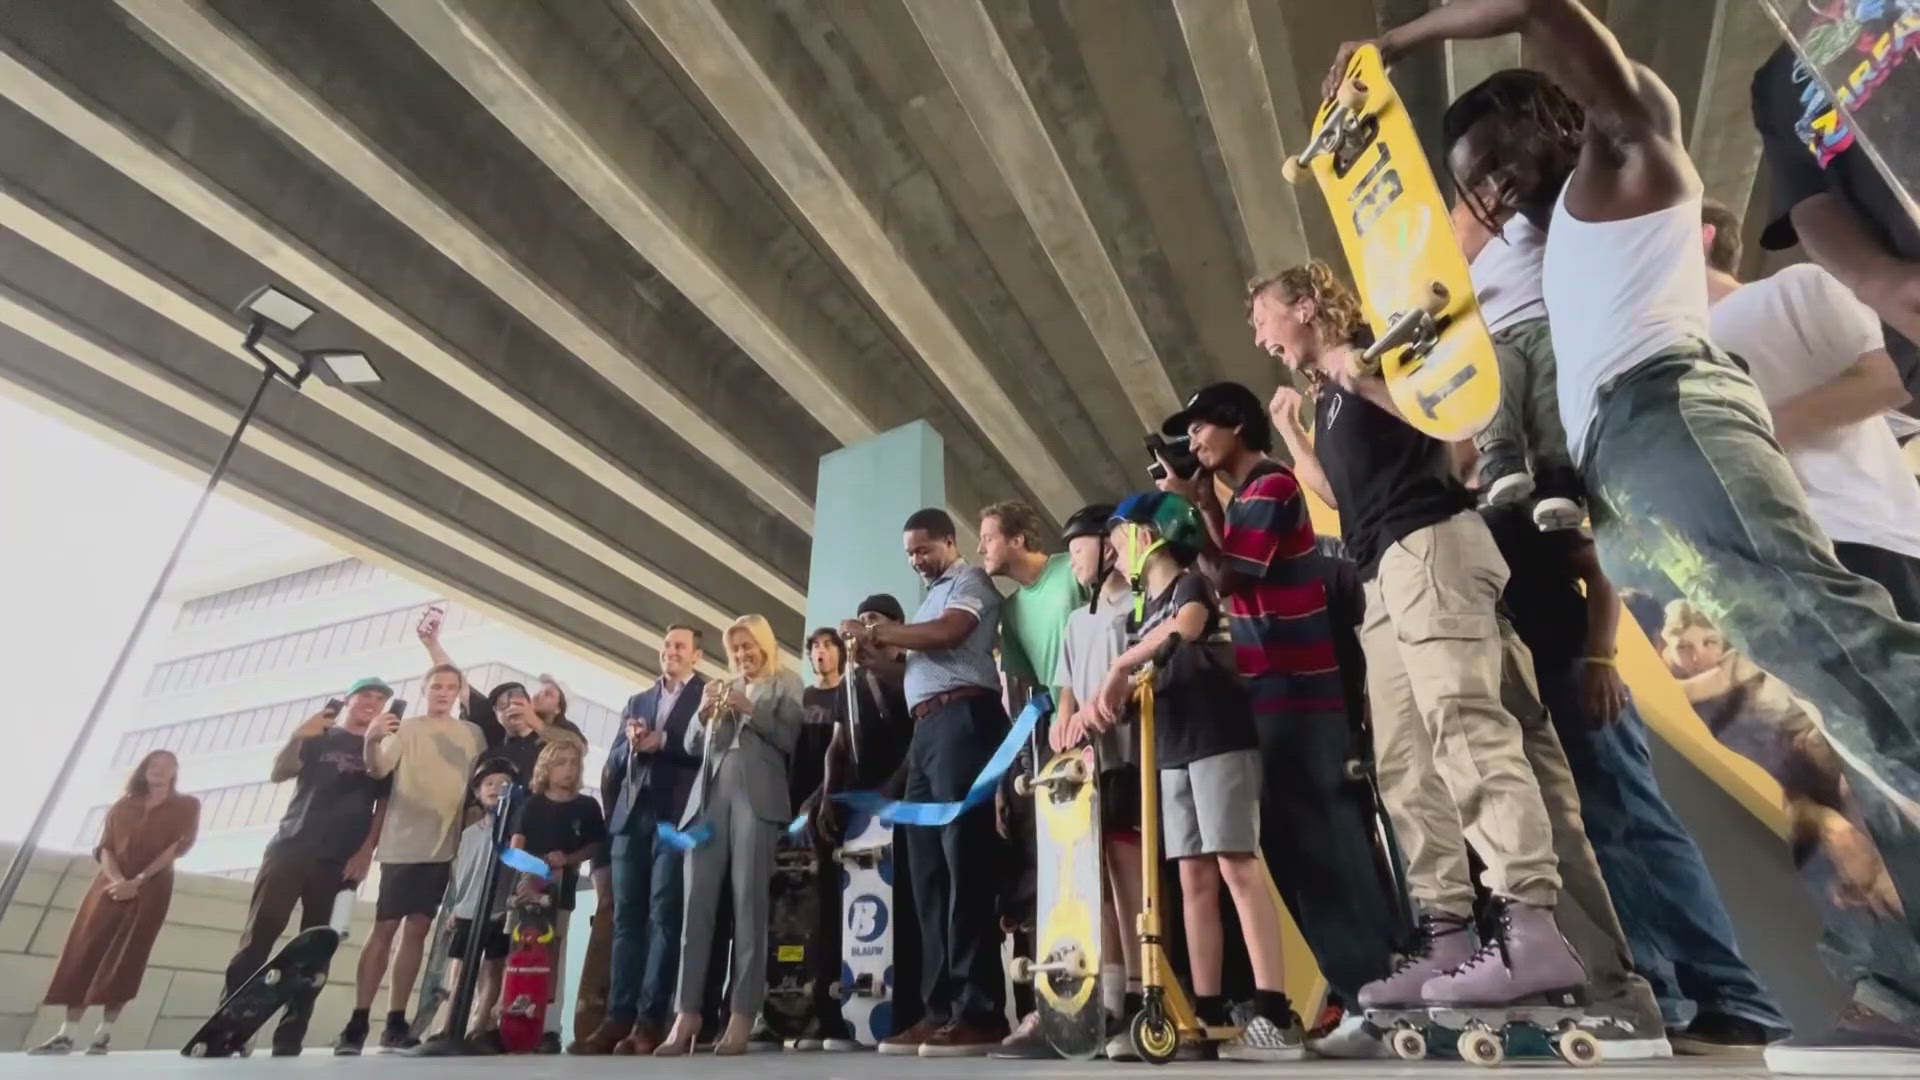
[1542,190,1709,463]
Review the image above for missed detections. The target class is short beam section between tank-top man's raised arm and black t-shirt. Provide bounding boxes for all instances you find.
[1688,0,1780,217]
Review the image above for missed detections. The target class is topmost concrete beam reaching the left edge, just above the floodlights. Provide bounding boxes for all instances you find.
[0,40,804,611]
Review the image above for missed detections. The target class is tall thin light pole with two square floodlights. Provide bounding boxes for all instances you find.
[0,284,380,913]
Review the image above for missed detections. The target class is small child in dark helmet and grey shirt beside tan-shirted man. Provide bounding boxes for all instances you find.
[411,757,515,1057]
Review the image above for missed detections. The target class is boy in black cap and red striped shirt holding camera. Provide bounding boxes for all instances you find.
[1160,382,1398,1049]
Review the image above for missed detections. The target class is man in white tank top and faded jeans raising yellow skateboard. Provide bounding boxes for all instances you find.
[1351,0,1920,1074]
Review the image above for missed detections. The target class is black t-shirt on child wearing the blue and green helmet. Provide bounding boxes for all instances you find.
[1127,569,1258,769]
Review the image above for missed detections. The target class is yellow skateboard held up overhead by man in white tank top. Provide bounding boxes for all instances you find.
[1283,44,1500,442]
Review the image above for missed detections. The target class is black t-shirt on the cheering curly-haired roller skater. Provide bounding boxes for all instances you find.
[1313,386,1473,580]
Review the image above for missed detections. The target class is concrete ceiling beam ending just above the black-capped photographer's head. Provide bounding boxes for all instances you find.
[906,0,1179,425]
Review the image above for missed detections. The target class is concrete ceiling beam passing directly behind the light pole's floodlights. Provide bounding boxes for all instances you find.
[0,183,771,657]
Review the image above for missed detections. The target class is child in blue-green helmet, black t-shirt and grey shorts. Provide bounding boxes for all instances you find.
[1098,492,1306,1061]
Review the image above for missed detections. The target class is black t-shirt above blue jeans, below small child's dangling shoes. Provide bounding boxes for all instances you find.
[1480,503,1594,669]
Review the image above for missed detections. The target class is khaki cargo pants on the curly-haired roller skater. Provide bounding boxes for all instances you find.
[1359,509,1561,917]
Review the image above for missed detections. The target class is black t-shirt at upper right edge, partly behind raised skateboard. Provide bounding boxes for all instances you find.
[1751,42,1920,396]
